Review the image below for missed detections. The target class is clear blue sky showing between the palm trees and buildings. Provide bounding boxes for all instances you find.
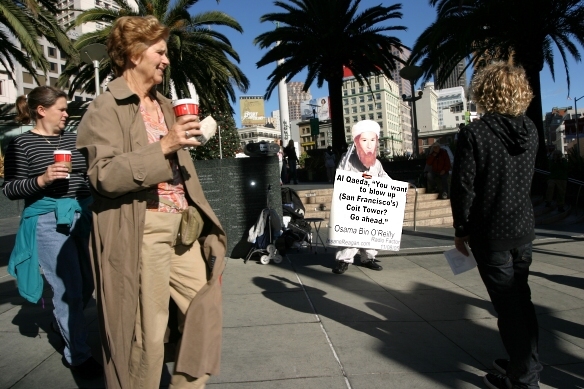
[191,0,584,126]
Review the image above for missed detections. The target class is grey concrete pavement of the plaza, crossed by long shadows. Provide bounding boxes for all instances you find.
[0,214,584,389]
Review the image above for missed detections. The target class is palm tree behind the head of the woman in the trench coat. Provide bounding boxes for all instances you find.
[59,0,249,113]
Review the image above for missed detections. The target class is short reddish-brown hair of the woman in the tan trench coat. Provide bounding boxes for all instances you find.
[107,15,170,77]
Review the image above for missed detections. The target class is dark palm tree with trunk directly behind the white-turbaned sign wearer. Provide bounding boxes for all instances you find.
[254,0,406,151]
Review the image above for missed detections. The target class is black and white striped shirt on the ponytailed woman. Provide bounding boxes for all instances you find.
[2,131,90,200]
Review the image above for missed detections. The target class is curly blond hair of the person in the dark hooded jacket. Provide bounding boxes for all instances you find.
[471,61,533,116]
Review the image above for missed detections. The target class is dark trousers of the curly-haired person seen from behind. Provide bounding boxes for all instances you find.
[473,242,542,388]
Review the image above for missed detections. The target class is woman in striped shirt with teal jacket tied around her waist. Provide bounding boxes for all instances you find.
[2,86,103,379]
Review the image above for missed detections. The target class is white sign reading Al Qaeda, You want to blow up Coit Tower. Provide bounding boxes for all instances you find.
[327,169,409,251]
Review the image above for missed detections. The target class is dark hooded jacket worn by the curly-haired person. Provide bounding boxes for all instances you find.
[450,114,538,251]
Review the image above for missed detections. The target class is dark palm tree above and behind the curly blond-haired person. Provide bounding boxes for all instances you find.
[410,0,584,163]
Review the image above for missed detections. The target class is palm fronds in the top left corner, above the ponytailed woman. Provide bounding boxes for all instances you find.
[0,0,74,83]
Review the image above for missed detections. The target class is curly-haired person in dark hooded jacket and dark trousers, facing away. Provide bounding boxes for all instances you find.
[450,62,542,389]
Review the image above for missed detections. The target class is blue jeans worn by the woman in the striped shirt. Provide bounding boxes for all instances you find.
[36,212,93,366]
